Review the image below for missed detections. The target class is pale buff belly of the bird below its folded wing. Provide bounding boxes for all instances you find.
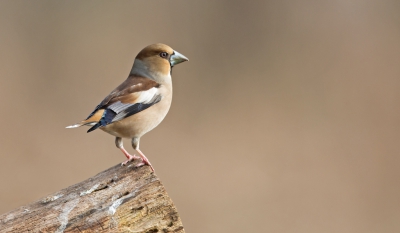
[100,98,170,138]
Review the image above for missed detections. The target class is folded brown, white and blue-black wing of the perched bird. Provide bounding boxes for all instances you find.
[84,76,162,132]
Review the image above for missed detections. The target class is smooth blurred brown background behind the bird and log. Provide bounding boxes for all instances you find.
[0,0,400,233]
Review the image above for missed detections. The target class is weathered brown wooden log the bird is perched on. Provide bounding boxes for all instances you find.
[0,164,184,233]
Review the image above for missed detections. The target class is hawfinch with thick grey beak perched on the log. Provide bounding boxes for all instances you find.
[66,43,189,171]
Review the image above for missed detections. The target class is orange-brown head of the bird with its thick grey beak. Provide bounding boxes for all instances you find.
[131,43,189,81]
